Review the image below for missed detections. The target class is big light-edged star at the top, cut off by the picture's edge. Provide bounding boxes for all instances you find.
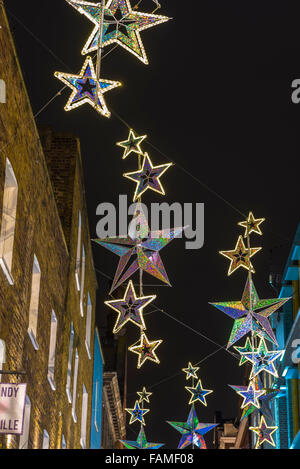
[68,0,170,64]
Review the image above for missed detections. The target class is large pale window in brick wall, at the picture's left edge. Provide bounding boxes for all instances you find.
[0,159,18,285]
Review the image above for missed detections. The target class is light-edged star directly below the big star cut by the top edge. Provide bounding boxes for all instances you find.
[54,57,121,117]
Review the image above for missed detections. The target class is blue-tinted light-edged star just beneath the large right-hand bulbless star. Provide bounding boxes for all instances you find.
[242,338,284,379]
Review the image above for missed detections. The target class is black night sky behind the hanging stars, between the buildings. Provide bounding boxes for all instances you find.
[6,0,300,448]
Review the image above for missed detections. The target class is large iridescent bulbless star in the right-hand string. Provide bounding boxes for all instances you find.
[211,279,290,348]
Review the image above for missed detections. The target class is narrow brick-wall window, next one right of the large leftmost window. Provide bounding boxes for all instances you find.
[28,255,41,350]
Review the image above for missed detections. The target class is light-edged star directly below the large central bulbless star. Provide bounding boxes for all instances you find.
[105,280,156,334]
